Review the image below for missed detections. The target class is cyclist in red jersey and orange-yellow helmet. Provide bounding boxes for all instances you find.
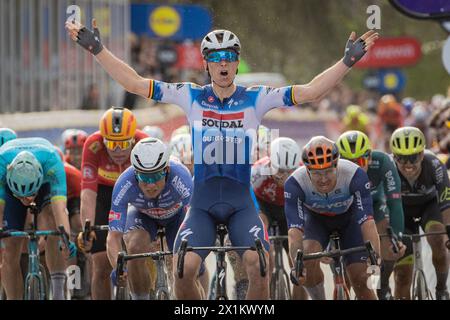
[78,107,147,300]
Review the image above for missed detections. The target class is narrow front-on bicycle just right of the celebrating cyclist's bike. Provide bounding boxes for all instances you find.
[269,223,291,300]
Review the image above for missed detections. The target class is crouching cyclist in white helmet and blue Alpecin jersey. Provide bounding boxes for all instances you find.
[107,138,207,300]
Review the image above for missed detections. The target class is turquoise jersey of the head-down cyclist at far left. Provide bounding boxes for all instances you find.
[0,138,67,202]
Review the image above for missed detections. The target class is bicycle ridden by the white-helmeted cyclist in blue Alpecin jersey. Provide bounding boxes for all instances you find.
[116,226,172,300]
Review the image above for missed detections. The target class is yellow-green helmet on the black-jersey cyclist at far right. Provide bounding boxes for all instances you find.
[390,127,425,156]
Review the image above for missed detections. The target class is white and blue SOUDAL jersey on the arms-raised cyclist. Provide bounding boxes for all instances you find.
[148,80,296,187]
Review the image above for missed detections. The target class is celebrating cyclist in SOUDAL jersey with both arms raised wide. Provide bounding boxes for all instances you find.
[66,20,378,299]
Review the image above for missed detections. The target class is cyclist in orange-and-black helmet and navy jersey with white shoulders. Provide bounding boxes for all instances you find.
[284,136,380,300]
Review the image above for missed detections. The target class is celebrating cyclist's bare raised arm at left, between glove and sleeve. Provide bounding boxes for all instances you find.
[95,48,148,95]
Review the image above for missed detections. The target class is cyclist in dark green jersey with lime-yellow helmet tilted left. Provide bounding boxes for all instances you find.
[336,131,406,300]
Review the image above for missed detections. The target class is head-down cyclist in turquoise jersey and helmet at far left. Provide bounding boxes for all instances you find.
[0,138,76,300]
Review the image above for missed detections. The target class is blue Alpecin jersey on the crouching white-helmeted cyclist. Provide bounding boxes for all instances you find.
[109,160,192,232]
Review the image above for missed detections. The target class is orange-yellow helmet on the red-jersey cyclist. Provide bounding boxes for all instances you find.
[100,107,137,141]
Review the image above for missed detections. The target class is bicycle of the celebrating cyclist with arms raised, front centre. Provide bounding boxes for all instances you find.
[177,224,266,300]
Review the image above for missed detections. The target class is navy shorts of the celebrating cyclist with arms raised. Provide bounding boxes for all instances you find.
[174,177,269,260]
